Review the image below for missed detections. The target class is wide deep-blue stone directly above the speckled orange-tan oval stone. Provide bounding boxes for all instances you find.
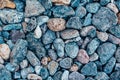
[52,5,75,17]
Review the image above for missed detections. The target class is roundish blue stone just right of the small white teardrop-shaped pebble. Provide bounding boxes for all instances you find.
[42,30,56,44]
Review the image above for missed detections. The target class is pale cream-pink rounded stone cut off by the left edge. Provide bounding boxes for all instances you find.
[0,43,11,60]
